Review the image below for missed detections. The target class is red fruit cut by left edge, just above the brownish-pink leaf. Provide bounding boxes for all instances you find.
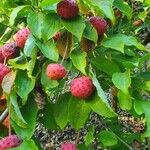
[0,63,11,84]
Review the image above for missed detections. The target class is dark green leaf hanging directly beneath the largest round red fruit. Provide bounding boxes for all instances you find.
[69,97,91,129]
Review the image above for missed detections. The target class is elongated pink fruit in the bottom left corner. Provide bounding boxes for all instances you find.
[0,135,21,150]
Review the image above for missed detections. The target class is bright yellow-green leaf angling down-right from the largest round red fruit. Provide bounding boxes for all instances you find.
[86,93,116,118]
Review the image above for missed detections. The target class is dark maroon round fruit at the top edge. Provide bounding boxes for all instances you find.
[57,0,79,19]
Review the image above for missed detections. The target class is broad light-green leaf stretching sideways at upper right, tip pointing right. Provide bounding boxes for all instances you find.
[102,34,145,53]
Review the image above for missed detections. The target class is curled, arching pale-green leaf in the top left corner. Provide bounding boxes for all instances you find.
[9,5,31,26]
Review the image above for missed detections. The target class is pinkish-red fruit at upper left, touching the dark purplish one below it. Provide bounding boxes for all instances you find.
[15,27,30,48]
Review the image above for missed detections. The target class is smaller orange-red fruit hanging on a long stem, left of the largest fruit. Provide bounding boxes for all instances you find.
[46,64,67,80]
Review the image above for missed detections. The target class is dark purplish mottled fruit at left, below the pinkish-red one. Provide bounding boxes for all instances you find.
[2,42,19,59]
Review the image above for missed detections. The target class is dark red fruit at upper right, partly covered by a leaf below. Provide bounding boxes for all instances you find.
[89,16,107,36]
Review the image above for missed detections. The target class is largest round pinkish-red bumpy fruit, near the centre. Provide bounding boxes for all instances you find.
[70,76,94,99]
